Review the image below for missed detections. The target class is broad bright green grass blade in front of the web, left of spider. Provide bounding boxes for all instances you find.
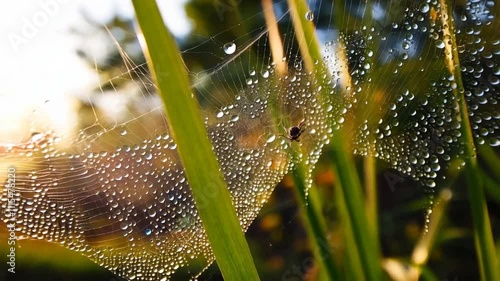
[132,0,259,280]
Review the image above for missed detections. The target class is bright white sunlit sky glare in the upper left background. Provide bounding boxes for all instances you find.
[0,0,190,143]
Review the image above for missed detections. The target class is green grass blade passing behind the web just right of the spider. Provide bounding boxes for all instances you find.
[288,0,381,280]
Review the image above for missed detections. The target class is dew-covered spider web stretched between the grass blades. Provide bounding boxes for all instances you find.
[0,1,500,280]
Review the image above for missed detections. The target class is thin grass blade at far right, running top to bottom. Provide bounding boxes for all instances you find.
[439,0,500,280]
